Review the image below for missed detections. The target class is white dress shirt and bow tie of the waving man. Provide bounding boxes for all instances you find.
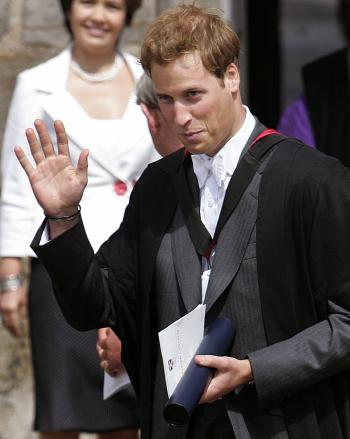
[191,105,255,302]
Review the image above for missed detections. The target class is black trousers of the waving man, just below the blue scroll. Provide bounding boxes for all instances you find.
[186,400,235,439]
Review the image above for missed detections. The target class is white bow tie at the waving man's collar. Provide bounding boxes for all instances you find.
[191,151,226,189]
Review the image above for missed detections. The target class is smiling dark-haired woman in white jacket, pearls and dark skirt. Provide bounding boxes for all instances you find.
[0,0,154,439]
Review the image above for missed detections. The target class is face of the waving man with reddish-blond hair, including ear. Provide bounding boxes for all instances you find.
[151,52,244,155]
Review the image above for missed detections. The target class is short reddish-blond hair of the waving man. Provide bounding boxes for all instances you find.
[141,5,240,78]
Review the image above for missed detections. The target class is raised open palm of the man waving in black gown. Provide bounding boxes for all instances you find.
[15,119,89,217]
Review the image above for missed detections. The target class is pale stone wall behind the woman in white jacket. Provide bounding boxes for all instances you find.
[0,0,220,439]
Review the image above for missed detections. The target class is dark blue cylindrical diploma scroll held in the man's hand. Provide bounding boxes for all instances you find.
[163,317,235,425]
